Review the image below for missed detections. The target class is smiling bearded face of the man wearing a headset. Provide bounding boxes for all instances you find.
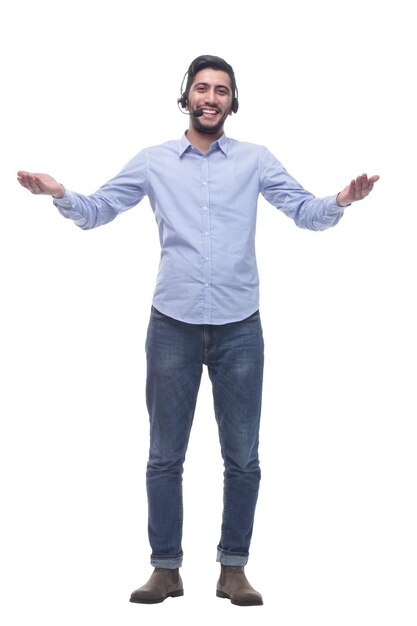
[187,67,233,135]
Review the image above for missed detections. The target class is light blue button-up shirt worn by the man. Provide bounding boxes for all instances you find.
[54,135,343,324]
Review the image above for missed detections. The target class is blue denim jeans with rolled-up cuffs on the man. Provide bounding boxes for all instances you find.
[146,307,264,569]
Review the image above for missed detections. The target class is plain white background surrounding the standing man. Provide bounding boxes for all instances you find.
[0,0,417,626]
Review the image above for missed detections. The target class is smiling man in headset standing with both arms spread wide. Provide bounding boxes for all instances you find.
[18,55,378,606]
